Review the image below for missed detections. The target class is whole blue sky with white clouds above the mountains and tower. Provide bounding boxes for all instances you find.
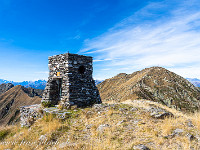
[0,0,200,81]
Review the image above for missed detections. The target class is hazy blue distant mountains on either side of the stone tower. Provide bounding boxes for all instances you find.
[0,79,103,90]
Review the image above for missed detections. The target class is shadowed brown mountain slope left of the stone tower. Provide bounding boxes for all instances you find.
[0,85,41,125]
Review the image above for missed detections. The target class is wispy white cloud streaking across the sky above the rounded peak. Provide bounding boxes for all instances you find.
[80,0,200,78]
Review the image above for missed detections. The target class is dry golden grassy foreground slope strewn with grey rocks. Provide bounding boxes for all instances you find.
[0,100,200,150]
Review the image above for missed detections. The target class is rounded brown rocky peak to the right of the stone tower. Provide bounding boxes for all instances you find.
[97,67,200,111]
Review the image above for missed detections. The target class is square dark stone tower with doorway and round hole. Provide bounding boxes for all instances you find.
[42,53,101,107]
